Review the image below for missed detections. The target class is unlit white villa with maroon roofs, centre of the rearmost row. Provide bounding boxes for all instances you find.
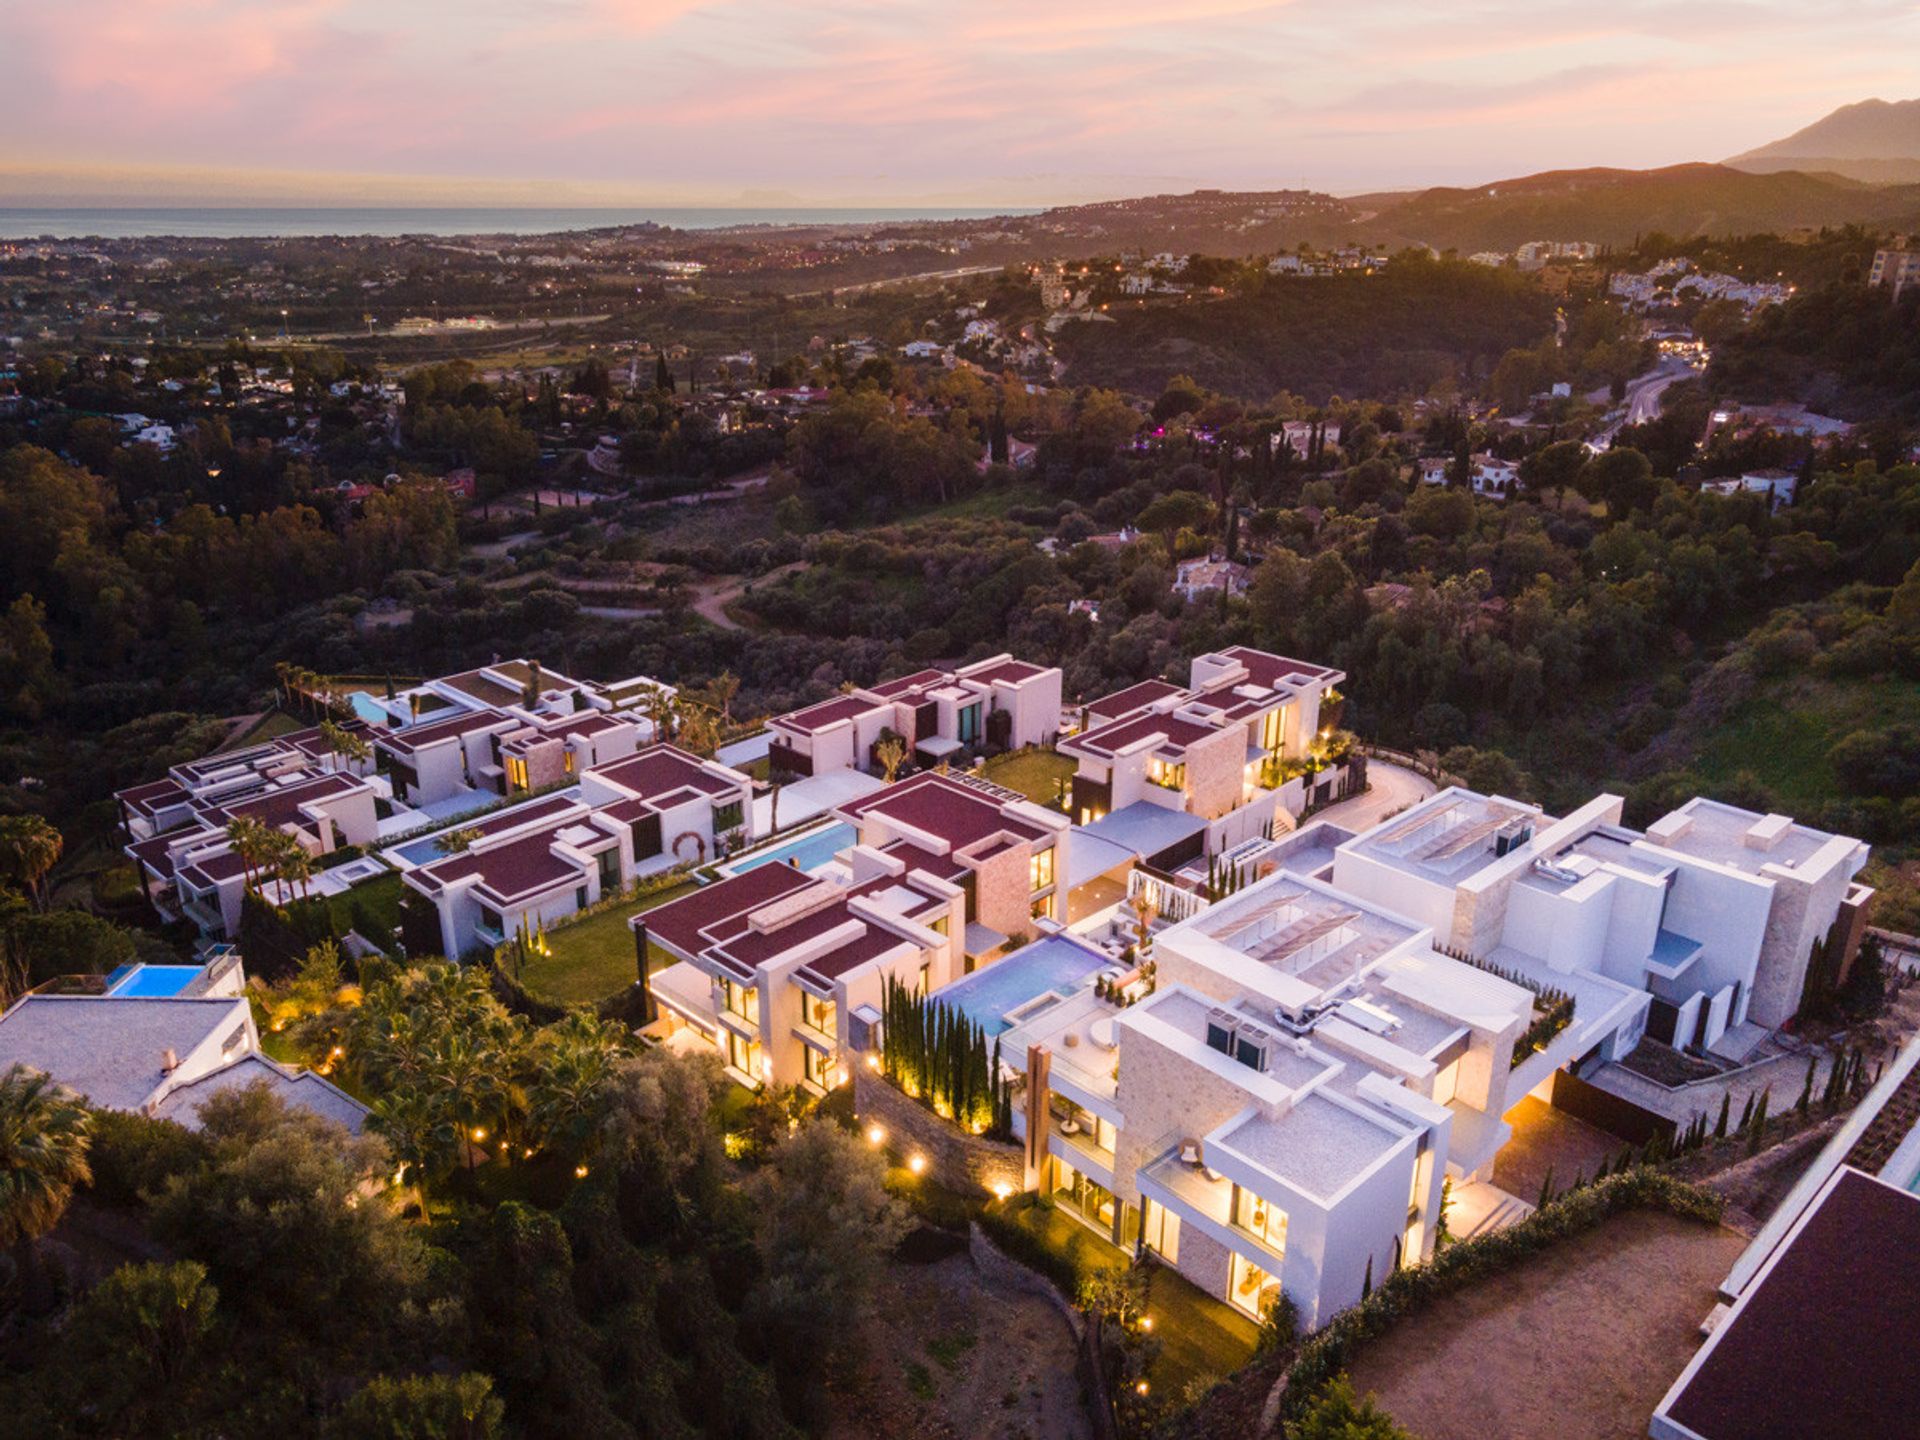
[768,655,1060,776]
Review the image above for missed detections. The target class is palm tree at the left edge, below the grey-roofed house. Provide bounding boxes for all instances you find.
[0,1066,94,1315]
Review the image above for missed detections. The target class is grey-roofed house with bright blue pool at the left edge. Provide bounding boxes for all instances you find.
[0,950,367,1135]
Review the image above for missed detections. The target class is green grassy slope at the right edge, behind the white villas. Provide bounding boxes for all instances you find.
[1695,676,1920,816]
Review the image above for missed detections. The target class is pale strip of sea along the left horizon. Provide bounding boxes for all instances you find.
[0,205,1039,240]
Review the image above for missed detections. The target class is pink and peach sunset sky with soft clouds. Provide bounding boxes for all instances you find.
[0,0,1920,205]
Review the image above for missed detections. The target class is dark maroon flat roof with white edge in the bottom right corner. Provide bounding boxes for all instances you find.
[1655,1169,1920,1440]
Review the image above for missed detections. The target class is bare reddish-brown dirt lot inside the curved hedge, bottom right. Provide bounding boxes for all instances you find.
[1354,1210,1745,1440]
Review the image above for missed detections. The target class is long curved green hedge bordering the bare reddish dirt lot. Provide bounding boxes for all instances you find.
[1281,1169,1720,1421]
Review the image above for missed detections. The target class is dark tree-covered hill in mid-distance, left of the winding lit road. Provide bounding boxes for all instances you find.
[1054,261,1553,403]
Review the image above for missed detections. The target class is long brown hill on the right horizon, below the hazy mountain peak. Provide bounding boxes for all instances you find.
[1365,165,1920,252]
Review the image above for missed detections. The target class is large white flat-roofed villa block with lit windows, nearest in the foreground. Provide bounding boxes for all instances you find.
[848,789,1868,1325]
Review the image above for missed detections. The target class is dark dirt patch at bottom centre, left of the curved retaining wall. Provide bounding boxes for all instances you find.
[826,1254,1091,1440]
